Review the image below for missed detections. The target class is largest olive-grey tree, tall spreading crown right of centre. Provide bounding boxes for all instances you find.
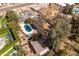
[49,16,71,51]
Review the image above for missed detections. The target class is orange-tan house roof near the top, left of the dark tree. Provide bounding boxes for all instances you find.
[39,4,59,18]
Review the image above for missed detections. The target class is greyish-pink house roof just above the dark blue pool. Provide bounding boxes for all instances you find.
[19,10,38,22]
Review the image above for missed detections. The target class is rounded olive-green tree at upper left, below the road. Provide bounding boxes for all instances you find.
[6,10,18,21]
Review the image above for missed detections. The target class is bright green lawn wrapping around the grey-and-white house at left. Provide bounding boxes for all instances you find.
[0,20,19,55]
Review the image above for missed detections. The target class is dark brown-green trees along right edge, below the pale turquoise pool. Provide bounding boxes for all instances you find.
[70,17,79,42]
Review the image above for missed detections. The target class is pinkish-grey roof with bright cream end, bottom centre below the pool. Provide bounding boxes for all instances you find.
[30,41,49,56]
